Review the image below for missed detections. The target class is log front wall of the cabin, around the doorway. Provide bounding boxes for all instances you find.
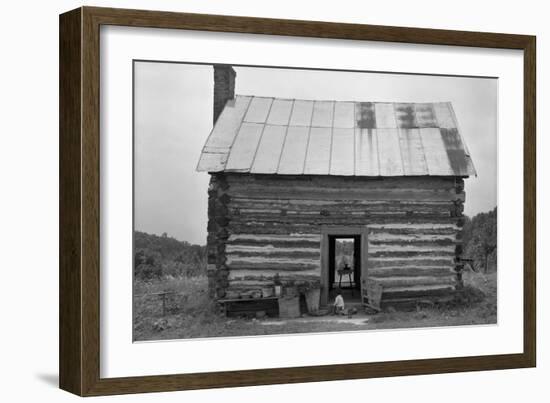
[207,173,465,299]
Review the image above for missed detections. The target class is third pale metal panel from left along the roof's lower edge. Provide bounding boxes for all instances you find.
[250,125,287,174]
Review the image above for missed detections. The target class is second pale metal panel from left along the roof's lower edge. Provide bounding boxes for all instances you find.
[225,123,264,172]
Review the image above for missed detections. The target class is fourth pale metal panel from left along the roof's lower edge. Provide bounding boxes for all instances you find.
[277,126,309,175]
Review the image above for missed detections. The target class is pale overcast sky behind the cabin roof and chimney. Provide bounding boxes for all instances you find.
[134,62,498,245]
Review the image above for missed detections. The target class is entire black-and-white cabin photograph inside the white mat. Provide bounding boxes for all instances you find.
[133,60,498,342]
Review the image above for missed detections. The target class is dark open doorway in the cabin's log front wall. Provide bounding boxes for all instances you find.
[328,235,361,301]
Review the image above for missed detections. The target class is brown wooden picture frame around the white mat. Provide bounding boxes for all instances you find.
[59,7,536,396]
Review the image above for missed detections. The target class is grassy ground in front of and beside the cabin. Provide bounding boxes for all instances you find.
[134,272,497,341]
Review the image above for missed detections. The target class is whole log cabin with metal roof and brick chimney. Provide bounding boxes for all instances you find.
[197,65,476,310]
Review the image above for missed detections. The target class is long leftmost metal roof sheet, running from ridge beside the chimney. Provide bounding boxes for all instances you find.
[203,97,251,152]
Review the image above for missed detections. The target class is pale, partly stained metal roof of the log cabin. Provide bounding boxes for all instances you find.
[197,95,476,176]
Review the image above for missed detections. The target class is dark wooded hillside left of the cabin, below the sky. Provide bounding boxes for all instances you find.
[134,231,206,280]
